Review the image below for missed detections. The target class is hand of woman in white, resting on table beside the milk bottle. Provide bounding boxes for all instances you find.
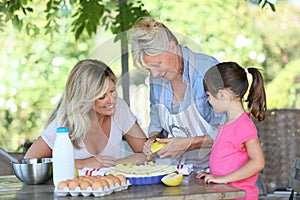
[75,155,118,169]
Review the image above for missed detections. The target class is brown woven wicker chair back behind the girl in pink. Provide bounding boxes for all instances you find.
[255,109,300,193]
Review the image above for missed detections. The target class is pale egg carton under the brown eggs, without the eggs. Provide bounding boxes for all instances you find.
[54,180,131,197]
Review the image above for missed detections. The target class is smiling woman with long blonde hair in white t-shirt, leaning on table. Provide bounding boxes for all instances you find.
[25,60,147,169]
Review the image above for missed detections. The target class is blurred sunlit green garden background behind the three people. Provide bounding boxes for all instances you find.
[0,0,300,151]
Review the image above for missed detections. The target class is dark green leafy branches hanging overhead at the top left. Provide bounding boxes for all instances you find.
[0,0,147,40]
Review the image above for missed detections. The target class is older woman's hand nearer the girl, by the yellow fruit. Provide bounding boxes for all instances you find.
[156,137,193,158]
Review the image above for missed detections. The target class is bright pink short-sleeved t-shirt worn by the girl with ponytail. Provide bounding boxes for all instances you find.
[209,112,259,200]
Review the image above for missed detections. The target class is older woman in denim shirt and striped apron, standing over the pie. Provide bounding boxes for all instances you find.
[128,17,225,170]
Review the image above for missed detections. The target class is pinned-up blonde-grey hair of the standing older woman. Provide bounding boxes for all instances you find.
[128,17,178,67]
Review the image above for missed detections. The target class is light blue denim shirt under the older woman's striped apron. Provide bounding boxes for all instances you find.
[148,46,226,139]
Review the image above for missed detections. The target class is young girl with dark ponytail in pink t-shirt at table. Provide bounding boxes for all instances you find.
[196,62,266,200]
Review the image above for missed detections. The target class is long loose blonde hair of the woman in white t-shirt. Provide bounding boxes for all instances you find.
[47,59,116,149]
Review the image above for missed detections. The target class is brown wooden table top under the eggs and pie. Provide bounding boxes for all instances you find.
[0,174,245,200]
